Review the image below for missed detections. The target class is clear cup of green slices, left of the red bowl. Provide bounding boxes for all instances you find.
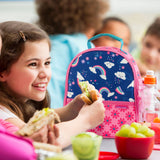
[72,132,102,160]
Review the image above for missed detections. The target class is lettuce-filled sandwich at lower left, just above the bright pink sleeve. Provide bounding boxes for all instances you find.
[17,108,60,136]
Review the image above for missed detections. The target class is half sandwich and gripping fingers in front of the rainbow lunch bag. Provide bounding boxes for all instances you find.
[79,81,105,129]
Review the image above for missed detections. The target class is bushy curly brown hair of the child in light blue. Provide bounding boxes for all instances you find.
[36,0,109,34]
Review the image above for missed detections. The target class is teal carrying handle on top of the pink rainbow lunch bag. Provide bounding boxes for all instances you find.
[87,33,123,50]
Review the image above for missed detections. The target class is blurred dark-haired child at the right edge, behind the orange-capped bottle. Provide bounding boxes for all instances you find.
[133,17,160,89]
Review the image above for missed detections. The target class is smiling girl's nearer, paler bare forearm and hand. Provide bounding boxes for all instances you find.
[56,99,105,148]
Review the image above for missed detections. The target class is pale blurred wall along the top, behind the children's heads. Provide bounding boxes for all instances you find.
[0,0,160,42]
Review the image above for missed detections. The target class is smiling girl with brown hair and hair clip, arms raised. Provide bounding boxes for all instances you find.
[0,21,105,148]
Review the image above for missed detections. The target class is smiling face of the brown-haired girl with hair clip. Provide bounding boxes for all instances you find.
[3,40,51,101]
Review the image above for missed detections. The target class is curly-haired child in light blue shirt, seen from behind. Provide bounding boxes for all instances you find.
[36,0,108,108]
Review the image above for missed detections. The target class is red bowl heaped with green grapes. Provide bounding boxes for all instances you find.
[115,122,155,159]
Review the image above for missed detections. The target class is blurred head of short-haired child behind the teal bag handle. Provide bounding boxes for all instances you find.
[92,17,131,52]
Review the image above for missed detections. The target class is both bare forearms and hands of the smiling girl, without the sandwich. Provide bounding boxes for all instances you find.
[56,82,105,148]
